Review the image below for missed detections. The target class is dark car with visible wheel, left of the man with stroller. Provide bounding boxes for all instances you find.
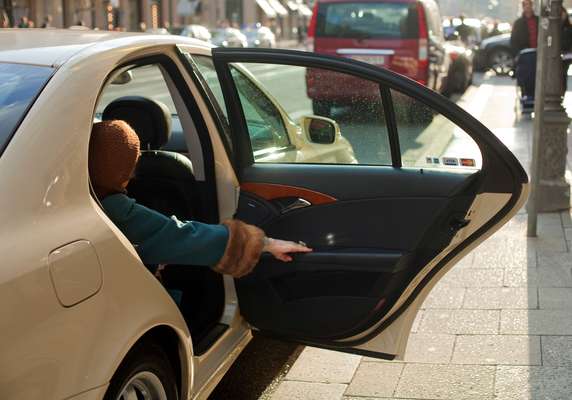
[475,33,516,75]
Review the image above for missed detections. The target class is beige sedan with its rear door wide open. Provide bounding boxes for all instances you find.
[0,30,528,400]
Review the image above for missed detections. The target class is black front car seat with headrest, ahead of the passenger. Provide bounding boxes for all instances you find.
[102,96,198,220]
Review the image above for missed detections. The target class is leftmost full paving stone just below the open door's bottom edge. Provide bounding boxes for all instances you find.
[286,347,361,383]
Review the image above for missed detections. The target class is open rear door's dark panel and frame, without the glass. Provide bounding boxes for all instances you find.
[201,49,527,357]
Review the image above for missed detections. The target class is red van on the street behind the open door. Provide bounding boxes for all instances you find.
[307,0,450,114]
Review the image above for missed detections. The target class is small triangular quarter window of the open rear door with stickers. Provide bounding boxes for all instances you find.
[391,90,482,171]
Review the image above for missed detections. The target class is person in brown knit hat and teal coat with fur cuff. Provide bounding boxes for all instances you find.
[89,120,311,278]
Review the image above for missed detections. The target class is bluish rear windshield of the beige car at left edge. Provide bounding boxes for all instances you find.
[0,63,53,154]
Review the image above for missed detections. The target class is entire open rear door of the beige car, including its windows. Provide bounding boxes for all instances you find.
[184,49,528,358]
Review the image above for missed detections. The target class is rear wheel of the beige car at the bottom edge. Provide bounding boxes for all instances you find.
[104,341,179,400]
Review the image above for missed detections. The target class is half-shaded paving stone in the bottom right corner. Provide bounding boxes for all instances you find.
[495,366,572,400]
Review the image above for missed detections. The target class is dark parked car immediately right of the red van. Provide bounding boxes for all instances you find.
[443,41,475,95]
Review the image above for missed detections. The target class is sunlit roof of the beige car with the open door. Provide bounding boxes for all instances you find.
[0,29,208,67]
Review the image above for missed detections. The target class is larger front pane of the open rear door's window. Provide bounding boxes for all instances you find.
[231,63,392,165]
